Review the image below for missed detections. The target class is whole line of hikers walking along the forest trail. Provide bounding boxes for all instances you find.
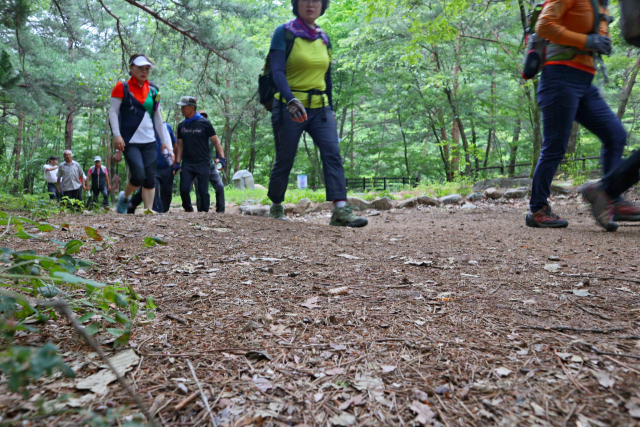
[47,0,640,231]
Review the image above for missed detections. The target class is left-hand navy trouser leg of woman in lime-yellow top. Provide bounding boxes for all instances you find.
[267,100,309,204]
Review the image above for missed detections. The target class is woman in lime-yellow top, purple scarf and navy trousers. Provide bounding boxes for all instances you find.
[268,0,368,227]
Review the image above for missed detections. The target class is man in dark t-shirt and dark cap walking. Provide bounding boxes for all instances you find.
[173,96,224,212]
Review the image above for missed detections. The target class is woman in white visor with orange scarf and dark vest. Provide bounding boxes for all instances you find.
[109,54,173,214]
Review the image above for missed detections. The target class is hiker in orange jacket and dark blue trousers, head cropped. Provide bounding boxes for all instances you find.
[526,0,640,228]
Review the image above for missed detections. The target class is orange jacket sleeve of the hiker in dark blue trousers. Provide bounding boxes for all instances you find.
[536,0,593,49]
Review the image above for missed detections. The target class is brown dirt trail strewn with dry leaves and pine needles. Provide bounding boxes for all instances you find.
[0,201,640,427]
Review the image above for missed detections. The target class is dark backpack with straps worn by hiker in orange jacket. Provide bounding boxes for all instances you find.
[522,0,604,82]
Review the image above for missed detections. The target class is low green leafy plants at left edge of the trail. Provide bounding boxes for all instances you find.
[0,211,159,391]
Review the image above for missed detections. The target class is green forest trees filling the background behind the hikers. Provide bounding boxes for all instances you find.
[0,0,640,194]
